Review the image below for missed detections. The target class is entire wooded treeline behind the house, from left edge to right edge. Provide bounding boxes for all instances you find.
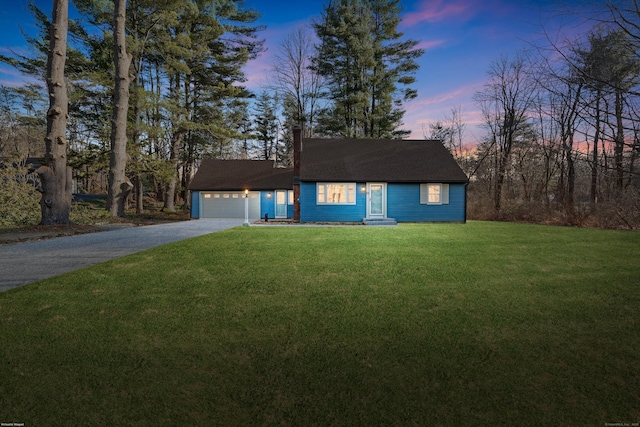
[0,0,640,228]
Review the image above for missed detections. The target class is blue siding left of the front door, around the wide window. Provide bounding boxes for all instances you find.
[300,182,367,222]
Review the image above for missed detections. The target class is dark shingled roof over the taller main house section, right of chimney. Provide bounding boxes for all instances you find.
[300,139,468,183]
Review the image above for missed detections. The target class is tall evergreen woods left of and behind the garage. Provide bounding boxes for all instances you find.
[0,0,262,221]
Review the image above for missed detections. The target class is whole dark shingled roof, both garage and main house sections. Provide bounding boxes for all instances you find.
[189,139,468,191]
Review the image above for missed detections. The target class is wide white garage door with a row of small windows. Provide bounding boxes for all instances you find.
[200,191,260,219]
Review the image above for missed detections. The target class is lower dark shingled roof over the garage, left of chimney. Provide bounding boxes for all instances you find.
[189,159,293,191]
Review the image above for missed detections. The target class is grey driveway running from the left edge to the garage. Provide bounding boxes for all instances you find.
[0,219,243,292]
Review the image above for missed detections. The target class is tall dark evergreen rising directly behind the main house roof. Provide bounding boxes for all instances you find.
[313,0,424,138]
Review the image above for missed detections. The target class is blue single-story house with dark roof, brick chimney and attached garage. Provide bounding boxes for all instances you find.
[189,129,468,223]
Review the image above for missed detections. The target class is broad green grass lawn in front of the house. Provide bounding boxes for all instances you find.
[0,222,640,426]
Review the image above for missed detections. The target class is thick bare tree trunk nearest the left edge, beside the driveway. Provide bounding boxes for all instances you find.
[36,0,71,225]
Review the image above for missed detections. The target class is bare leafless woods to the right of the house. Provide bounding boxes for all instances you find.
[425,1,640,229]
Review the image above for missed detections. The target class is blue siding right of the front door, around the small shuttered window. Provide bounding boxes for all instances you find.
[387,183,465,222]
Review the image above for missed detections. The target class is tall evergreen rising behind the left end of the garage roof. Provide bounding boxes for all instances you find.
[156,0,262,211]
